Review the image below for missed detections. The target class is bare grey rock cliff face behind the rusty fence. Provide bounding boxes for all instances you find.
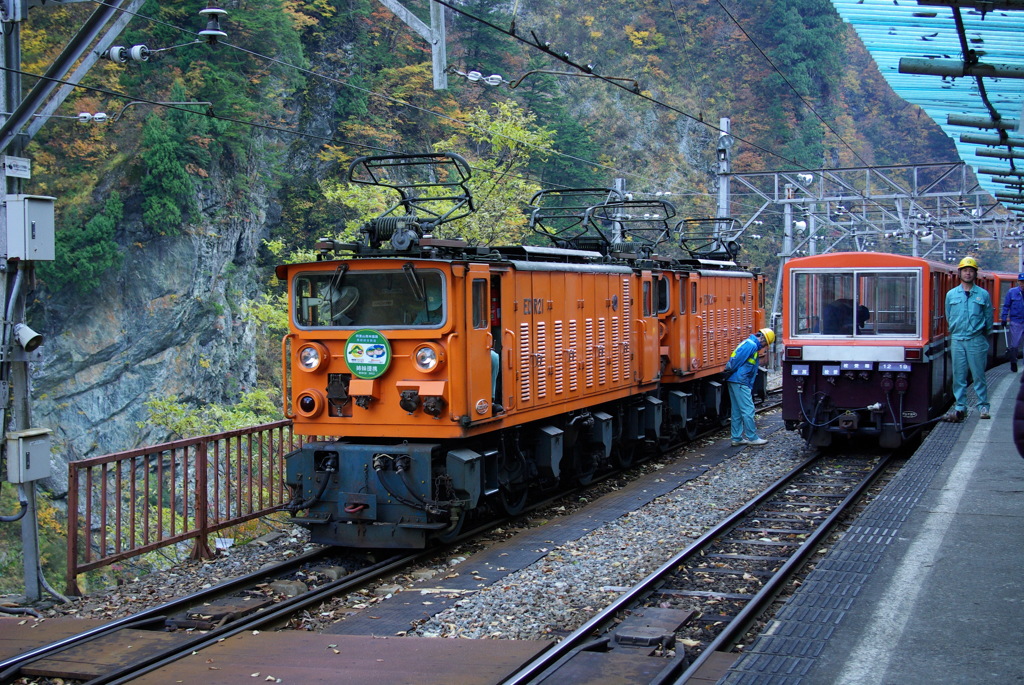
[29,159,272,491]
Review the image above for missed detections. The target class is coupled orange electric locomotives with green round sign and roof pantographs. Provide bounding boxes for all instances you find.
[278,155,764,548]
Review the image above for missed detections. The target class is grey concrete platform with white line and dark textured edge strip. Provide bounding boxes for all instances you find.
[719,365,1024,685]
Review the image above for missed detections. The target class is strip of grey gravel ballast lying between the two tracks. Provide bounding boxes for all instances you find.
[411,419,804,640]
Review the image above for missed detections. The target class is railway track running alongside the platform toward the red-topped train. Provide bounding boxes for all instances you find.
[503,448,889,685]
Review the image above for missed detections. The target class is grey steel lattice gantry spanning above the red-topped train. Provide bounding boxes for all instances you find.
[720,162,1024,327]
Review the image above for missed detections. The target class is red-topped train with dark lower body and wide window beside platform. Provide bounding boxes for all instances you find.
[782,252,998,447]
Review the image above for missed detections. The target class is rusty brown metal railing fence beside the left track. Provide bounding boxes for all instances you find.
[67,421,314,595]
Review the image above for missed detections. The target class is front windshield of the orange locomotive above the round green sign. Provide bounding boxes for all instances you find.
[292,266,445,329]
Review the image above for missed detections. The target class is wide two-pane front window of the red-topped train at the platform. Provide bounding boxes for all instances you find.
[790,270,921,337]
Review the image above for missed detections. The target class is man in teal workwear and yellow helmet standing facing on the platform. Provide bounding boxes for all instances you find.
[945,257,992,422]
